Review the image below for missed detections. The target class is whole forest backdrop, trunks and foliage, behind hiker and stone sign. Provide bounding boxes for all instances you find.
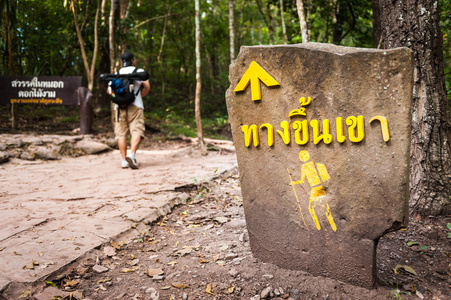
[0,0,451,215]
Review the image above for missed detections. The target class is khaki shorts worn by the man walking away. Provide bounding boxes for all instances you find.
[114,104,146,139]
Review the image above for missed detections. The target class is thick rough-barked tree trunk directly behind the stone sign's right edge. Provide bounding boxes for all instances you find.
[373,0,451,215]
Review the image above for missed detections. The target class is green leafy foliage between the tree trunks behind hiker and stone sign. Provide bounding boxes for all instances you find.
[0,0,451,136]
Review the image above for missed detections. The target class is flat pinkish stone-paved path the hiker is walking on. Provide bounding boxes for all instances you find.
[0,141,237,292]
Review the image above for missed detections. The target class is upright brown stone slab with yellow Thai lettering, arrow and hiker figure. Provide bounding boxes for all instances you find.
[226,43,413,288]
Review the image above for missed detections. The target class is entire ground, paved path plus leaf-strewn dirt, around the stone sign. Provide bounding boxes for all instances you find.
[0,137,451,300]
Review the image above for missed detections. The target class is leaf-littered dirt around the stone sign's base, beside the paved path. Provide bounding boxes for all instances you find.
[3,174,450,300]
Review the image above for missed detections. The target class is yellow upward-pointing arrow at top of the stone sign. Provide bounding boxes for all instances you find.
[233,61,280,101]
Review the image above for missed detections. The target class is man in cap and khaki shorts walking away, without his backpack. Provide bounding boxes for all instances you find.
[108,51,150,169]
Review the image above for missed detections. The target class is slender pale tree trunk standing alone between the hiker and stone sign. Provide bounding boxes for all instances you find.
[194,0,205,150]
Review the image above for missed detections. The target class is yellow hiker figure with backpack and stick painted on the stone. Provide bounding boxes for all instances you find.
[290,150,337,231]
